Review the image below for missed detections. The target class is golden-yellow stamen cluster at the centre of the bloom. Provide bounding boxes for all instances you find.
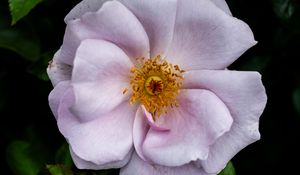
[130,55,184,120]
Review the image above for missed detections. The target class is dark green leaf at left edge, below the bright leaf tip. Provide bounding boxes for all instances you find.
[0,29,40,61]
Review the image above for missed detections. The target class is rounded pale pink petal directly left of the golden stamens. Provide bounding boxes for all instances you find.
[72,39,133,122]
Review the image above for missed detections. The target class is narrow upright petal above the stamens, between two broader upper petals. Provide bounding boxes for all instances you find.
[120,0,177,57]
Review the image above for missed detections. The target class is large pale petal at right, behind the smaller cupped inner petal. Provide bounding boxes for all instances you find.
[183,70,267,173]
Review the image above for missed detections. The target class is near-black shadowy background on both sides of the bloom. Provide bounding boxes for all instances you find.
[0,0,300,175]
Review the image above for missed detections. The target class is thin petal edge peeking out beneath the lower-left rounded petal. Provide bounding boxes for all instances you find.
[70,148,132,170]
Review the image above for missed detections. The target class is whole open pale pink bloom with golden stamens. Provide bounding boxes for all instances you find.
[48,0,267,175]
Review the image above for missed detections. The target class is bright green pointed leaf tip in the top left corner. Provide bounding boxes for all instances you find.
[8,0,42,25]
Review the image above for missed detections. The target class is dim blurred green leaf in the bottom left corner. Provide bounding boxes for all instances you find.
[7,140,43,175]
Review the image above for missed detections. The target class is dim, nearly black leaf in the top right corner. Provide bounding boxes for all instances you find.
[273,0,295,21]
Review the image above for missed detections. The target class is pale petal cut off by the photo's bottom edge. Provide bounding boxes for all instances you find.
[120,153,209,175]
